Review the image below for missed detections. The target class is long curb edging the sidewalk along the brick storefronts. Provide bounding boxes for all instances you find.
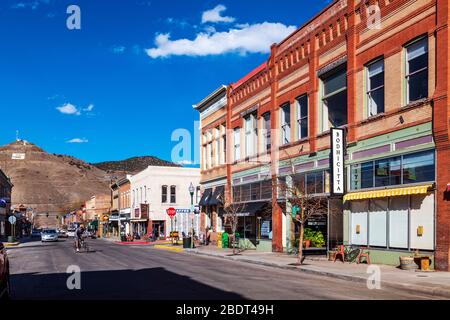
[186,250,450,299]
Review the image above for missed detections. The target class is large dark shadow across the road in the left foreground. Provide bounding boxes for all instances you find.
[11,266,244,300]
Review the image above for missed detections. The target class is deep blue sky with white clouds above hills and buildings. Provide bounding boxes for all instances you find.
[0,0,330,162]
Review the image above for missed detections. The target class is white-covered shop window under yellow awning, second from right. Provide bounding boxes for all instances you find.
[389,197,409,249]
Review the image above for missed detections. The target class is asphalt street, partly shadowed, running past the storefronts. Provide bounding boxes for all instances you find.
[8,240,433,300]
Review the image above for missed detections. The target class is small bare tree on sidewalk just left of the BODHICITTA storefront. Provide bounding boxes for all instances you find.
[278,176,328,264]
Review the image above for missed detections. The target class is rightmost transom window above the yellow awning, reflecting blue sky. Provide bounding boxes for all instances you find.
[403,151,435,184]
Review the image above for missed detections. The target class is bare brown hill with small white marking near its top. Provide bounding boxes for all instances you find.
[0,140,110,225]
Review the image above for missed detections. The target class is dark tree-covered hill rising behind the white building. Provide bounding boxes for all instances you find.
[92,156,179,175]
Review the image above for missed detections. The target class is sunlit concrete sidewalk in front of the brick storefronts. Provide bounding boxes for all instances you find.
[184,247,450,299]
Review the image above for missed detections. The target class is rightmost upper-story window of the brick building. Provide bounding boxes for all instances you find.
[406,37,428,103]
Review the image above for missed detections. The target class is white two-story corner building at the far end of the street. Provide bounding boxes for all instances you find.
[130,166,200,238]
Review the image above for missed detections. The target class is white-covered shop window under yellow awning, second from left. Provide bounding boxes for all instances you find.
[369,199,388,247]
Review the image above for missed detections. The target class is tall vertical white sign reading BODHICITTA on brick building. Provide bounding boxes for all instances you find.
[331,128,345,196]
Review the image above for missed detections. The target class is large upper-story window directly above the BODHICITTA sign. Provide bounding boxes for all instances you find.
[321,65,347,131]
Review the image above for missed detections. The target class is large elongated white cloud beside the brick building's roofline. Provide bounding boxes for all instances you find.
[146,22,296,59]
